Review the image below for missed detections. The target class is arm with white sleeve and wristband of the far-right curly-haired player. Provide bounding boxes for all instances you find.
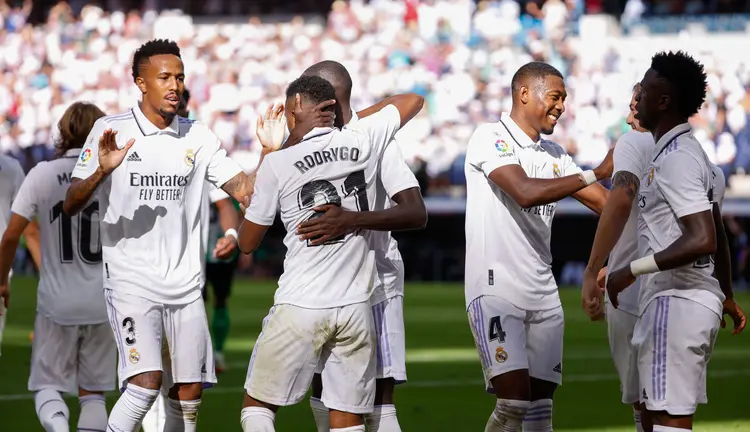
[607,152,716,307]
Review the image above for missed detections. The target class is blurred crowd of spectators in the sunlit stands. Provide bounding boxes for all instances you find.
[0,0,750,196]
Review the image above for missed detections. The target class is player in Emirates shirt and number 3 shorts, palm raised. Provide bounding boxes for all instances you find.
[64,39,268,432]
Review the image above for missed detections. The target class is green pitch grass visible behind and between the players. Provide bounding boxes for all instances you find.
[0,278,750,432]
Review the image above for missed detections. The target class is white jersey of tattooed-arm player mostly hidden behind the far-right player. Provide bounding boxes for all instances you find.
[604,131,656,316]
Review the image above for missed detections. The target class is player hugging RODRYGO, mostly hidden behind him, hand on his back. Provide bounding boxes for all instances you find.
[296,60,427,432]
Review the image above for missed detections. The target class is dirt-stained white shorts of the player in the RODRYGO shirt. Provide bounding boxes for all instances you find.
[245,302,375,414]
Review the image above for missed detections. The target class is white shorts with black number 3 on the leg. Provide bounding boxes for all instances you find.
[104,289,216,389]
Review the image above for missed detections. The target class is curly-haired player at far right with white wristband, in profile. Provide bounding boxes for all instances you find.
[607,52,745,432]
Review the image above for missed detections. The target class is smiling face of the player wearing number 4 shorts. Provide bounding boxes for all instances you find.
[530,75,568,135]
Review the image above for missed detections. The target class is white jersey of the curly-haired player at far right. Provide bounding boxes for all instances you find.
[638,123,724,316]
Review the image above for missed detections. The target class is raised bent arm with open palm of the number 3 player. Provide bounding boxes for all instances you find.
[63,119,135,216]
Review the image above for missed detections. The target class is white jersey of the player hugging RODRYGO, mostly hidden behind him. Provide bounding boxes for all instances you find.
[345,112,419,304]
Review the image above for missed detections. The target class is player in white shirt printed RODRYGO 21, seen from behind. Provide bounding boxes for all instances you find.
[239,76,423,432]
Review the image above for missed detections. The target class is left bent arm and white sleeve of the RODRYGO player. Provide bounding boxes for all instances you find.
[238,159,279,254]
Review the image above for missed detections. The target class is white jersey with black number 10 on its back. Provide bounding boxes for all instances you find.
[12,149,107,325]
